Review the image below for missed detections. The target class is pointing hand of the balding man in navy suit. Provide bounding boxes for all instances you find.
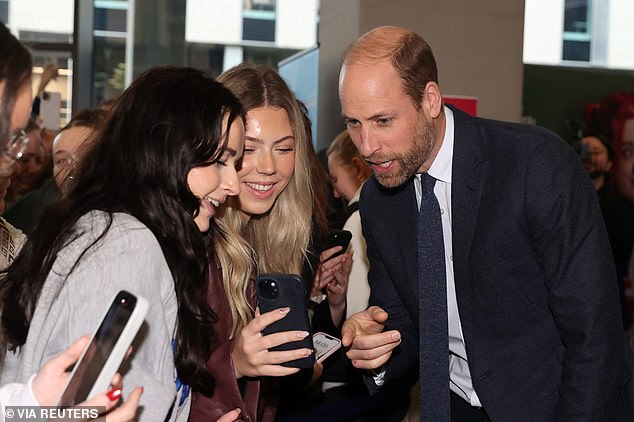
[341,306,401,369]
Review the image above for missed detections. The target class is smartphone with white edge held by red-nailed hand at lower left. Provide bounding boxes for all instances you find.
[58,290,149,407]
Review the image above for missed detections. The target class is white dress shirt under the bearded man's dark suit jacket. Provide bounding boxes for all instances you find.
[414,107,482,407]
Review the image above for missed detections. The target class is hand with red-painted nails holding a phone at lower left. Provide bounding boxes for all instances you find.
[28,337,143,422]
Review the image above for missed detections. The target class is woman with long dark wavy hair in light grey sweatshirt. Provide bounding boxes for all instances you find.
[0,66,244,422]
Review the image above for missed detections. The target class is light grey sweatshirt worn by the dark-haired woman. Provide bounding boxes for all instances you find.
[0,211,190,422]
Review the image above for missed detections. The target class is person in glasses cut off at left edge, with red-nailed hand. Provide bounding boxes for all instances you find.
[0,22,142,422]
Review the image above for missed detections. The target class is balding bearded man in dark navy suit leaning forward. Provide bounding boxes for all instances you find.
[339,26,634,422]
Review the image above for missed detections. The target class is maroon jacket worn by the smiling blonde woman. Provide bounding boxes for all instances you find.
[189,259,276,422]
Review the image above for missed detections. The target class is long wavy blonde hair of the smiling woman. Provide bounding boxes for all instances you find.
[216,63,313,336]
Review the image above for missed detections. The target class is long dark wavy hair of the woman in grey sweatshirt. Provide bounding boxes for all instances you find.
[0,66,245,395]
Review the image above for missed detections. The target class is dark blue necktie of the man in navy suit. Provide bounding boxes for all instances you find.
[418,173,450,422]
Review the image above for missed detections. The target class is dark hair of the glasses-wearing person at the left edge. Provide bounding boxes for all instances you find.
[0,22,33,149]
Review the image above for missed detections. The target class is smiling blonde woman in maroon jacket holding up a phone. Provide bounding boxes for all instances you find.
[190,64,349,421]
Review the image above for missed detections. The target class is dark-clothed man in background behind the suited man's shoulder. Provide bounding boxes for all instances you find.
[581,131,634,331]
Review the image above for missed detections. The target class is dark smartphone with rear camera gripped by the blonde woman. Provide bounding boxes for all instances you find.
[256,274,315,368]
